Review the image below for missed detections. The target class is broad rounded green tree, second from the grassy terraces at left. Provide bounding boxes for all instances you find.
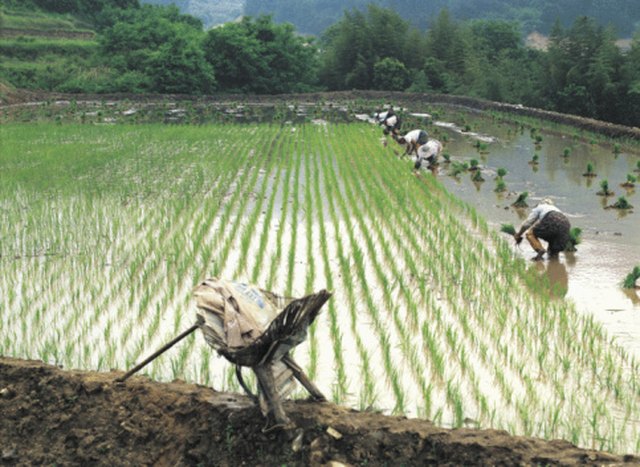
[203,16,317,94]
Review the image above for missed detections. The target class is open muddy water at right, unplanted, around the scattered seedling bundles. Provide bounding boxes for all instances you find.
[434,118,640,357]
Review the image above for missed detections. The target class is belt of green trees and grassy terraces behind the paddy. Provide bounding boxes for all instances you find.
[0,0,640,126]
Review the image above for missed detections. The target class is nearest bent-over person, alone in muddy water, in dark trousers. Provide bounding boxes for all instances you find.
[515,198,571,261]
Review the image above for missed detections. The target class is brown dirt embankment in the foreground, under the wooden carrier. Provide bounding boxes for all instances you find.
[0,357,640,466]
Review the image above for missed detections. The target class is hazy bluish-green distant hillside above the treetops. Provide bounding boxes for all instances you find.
[245,0,640,37]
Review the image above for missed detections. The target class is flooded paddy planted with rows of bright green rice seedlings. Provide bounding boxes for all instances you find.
[0,119,640,454]
